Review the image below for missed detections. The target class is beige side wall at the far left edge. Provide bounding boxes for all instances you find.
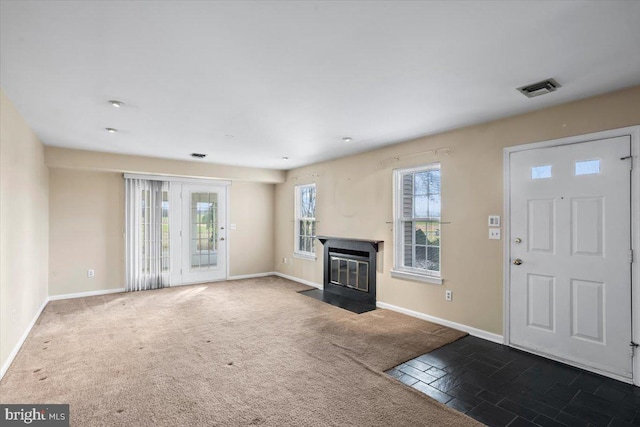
[0,91,49,367]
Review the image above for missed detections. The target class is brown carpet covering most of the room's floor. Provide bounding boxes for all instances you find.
[0,277,480,426]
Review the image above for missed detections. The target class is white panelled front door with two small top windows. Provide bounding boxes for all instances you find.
[509,136,632,378]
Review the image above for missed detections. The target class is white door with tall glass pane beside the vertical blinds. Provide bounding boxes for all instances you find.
[180,184,227,284]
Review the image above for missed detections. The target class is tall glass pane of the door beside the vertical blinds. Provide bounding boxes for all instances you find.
[189,193,218,269]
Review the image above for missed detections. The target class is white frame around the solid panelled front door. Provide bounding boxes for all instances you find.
[502,126,640,386]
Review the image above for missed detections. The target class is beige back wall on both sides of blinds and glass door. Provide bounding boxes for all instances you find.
[49,168,274,295]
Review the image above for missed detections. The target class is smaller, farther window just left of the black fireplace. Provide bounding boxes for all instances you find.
[294,184,316,258]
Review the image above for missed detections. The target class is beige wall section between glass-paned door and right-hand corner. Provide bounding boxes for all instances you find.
[229,181,275,276]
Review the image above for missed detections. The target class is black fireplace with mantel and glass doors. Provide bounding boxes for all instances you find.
[318,236,381,308]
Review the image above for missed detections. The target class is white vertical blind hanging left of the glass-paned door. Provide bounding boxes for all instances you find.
[125,178,170,292]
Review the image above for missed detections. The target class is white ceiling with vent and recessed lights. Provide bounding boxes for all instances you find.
[0,0,640,169]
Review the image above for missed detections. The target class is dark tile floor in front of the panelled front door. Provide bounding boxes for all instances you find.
[387,336,640,427]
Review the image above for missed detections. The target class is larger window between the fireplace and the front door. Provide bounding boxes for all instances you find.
[391,163,442,284]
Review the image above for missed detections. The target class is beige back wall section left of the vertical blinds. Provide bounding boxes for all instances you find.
[49,168,124,296]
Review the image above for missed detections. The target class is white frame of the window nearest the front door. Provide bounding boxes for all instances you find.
[391,162,443,285]
